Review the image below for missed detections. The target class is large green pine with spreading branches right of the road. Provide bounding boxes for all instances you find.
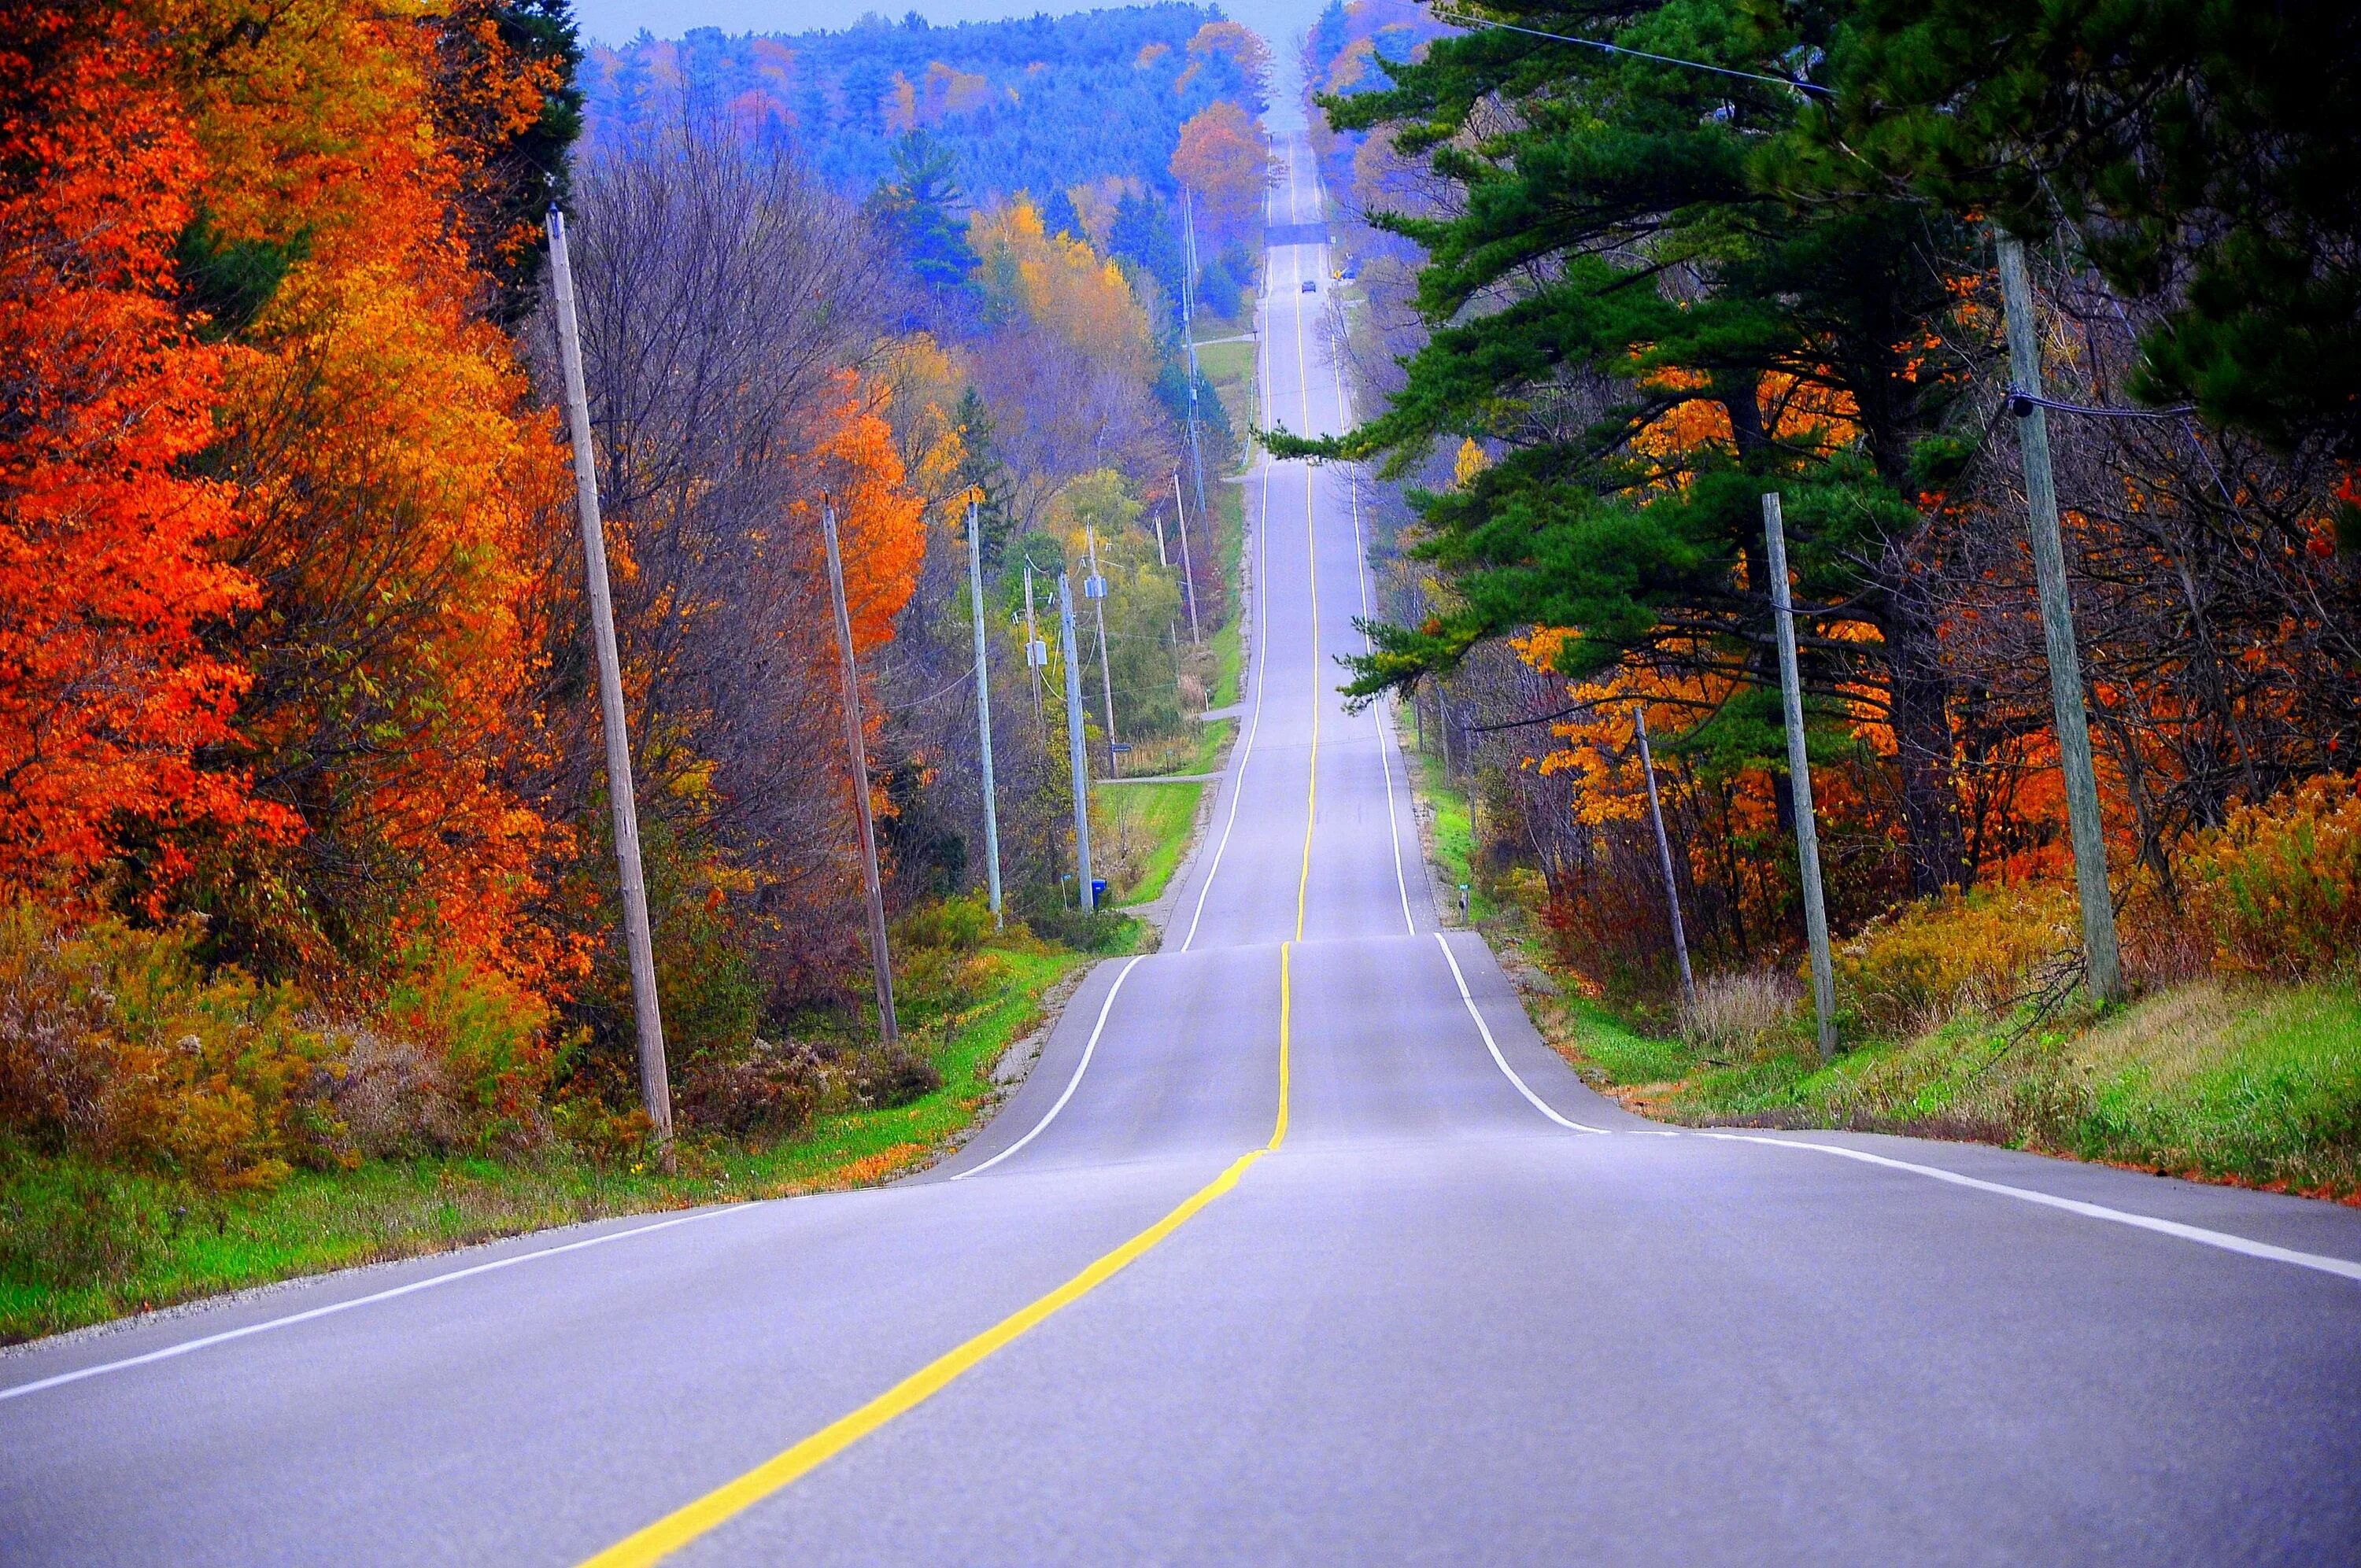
[1273,0,1974,891]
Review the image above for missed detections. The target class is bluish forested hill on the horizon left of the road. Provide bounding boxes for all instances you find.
[581,5,1263,198]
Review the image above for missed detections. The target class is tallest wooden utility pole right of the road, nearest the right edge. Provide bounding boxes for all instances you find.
[2000,231,2123,1002]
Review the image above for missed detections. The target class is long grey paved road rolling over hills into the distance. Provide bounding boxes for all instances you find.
[0,137,2361,1563]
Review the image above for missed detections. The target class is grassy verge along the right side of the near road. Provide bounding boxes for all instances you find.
[1535,980,2361,1197]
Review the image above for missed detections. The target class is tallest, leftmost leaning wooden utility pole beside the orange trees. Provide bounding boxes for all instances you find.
[550,208,673,1138]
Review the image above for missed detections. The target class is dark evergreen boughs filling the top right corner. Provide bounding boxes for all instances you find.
[1816,0,2361,456]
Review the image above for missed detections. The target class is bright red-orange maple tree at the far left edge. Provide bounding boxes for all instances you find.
[0,5,288,888]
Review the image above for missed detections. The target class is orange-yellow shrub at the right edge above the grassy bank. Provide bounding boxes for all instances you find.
[2182,774,2361,980]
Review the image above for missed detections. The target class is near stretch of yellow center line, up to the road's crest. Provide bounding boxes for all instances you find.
[583,943,1294,1568]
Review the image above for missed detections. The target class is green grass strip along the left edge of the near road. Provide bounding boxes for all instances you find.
[0,924,1086,1341]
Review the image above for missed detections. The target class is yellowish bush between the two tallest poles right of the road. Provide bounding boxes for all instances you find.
[1837,884,2080,1037]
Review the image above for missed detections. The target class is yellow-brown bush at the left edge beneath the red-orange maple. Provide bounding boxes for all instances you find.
[0,905,349,1190]
